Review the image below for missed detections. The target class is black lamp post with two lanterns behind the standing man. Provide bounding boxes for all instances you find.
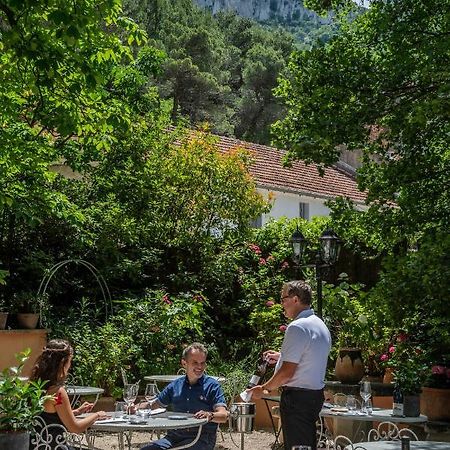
[291,226,341,317]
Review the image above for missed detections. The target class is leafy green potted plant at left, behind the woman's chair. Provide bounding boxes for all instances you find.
[0,349,50,450]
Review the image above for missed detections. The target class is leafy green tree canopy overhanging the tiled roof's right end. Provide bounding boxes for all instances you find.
[274,0,450,247]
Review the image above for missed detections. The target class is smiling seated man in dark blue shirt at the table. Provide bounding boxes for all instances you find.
[141,343,228,450]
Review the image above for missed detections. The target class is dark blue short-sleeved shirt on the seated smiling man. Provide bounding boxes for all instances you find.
[158,375,227,433]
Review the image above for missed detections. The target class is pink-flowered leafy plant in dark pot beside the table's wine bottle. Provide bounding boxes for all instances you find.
[381,333,430,417]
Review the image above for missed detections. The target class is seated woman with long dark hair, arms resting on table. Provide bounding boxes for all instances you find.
[30,339,108,448]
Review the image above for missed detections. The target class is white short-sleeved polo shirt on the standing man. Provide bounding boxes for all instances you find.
[275,309,331,390]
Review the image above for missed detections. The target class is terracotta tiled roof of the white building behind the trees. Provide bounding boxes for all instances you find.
[214,136,366,203]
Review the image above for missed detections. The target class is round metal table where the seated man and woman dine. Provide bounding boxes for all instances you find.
[86,412,208,450]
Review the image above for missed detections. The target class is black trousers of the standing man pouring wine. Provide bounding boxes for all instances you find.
[280,389,324,450]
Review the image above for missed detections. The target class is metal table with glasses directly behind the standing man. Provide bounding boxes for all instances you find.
[261,395,428,448]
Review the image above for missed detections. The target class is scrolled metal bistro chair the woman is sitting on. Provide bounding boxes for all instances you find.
[30,416,84,450]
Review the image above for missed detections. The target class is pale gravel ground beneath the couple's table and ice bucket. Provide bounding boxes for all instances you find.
[87,431,275,450]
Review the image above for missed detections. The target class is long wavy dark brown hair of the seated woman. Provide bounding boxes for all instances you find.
[30,339,73,389]
